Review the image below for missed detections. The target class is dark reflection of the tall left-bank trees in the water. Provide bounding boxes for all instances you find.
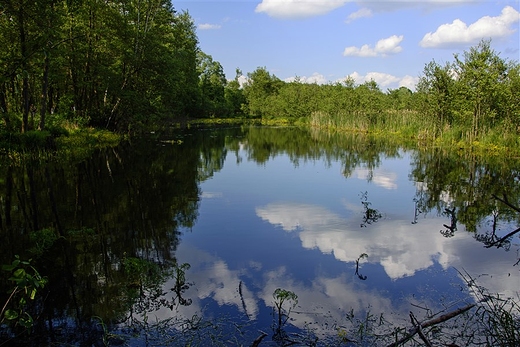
[0,130,207,343]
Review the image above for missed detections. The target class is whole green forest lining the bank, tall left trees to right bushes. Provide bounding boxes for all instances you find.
[0,0,520,148]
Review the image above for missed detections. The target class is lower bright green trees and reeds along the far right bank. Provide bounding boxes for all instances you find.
[243,41,520,147]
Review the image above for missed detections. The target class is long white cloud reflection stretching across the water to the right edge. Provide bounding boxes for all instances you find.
[256,203,520,296]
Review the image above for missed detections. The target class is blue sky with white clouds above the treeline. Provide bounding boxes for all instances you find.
[173,0,520,90]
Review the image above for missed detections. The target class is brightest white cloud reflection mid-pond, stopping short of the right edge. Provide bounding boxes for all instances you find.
[256,203,447,279]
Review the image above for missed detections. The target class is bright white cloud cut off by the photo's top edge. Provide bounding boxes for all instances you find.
[255,0,349,19]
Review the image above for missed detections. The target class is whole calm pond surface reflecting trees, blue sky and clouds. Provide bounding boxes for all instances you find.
[0,127,520,346]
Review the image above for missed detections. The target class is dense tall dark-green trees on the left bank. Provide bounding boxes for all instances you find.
[0,0,199,132]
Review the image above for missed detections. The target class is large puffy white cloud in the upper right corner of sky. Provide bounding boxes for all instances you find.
[419,6,520,48]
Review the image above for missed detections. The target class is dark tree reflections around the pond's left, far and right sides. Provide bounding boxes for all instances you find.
[0,127,520,346]
